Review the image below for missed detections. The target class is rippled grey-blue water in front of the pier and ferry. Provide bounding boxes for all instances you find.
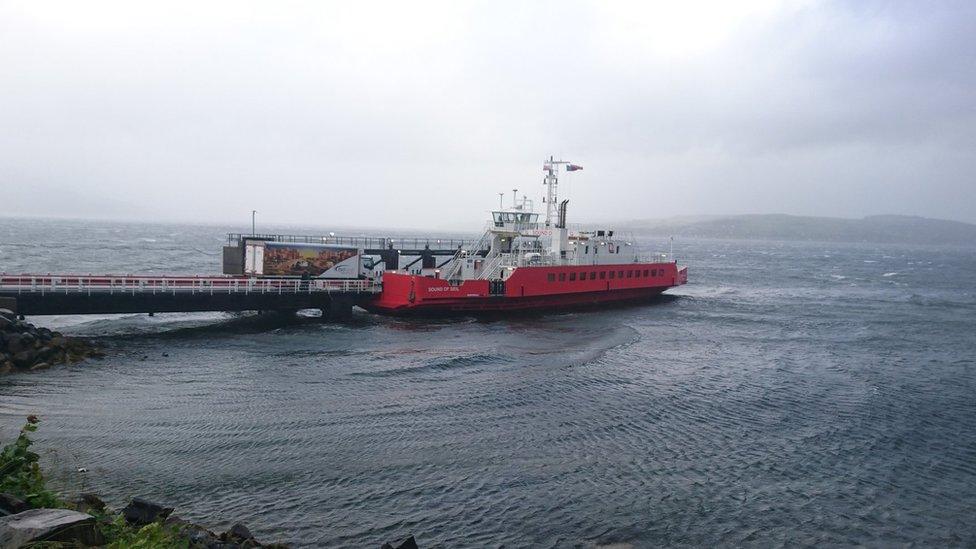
[0,228,976,547]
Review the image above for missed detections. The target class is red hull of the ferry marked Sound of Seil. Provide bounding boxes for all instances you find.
[366,263,688,315]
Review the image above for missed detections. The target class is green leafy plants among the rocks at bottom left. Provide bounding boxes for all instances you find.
[0,416,189,549]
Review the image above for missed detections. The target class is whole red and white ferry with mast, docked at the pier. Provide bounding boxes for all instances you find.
[365,157,688,315]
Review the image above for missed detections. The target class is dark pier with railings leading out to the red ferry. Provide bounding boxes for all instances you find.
[0,233,486,318]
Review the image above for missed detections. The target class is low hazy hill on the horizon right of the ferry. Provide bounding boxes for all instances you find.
[621,214,976,246]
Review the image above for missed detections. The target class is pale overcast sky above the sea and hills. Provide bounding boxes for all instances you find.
[0,0,976,230]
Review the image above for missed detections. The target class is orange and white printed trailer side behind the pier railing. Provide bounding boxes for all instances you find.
[261,242,360,278]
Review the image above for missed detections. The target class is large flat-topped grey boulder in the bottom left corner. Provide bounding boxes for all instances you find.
[0,509,105,547]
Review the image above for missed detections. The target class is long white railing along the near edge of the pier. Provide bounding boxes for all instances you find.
[0,274,381,295]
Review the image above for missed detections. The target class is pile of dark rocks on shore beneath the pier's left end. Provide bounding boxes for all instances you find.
[0,309,103,375]
